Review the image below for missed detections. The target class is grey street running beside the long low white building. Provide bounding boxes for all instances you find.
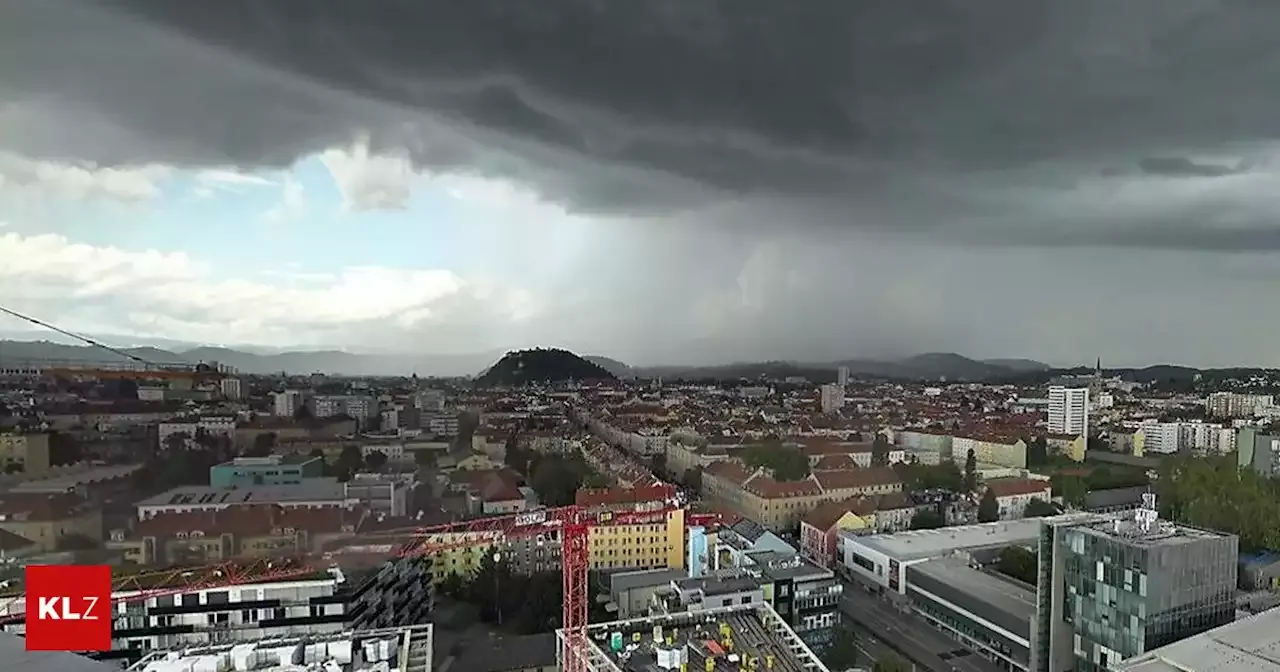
[840,586,998,672]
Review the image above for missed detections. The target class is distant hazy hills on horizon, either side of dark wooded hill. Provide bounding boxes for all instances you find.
[0,340,1218,383]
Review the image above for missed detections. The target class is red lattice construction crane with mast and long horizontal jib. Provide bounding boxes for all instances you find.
[0,499,718,672]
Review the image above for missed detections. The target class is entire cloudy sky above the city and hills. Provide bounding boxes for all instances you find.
[0,0,1280,367]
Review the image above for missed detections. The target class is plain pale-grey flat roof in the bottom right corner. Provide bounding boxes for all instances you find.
[1114,608,1280,672]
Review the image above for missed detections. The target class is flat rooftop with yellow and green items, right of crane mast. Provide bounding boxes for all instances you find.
[576,604,828,672]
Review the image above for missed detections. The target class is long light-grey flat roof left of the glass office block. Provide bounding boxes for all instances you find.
[840,518,1041,562]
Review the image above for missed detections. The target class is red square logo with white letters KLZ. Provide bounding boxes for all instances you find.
[26,564,114,652]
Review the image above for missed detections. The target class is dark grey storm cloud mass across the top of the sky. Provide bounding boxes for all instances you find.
[0,0,1280,247]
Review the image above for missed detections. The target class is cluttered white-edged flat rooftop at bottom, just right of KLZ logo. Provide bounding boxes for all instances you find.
[127,623,433,672]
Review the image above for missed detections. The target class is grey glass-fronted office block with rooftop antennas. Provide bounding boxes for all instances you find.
[1030,494,1239,672]
